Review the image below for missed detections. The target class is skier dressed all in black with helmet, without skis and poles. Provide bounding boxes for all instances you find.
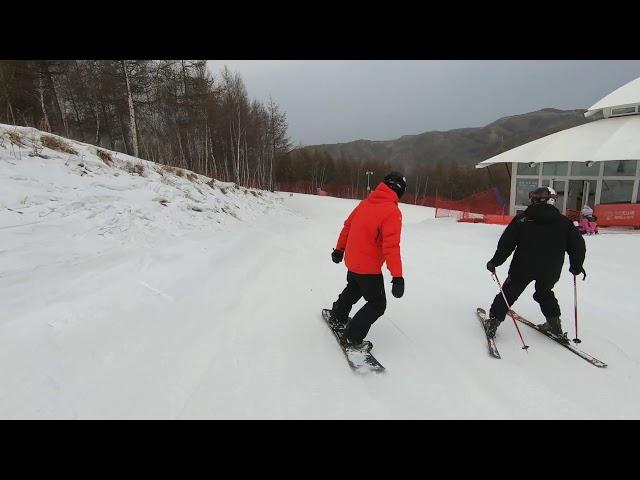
[486,187,586,338]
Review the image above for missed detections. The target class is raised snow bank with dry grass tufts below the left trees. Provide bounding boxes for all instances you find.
[0,124,281,243]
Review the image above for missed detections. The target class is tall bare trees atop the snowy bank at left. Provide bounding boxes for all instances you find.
[0,60,290,189]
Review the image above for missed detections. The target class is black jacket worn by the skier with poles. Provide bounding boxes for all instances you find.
[491,203,586,283]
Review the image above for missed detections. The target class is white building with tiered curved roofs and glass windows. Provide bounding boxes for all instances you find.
[476,78,640,215]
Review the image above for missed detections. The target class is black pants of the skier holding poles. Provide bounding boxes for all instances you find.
[489,275,560,322]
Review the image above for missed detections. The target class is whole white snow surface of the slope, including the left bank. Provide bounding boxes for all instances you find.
[0,125,640,419]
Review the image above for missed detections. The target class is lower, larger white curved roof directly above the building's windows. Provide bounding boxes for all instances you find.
[476,115,640,168]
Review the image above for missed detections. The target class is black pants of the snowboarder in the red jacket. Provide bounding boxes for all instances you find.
[332,272,387,343]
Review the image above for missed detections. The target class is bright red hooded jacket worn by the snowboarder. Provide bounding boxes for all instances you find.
[336,183,402,277]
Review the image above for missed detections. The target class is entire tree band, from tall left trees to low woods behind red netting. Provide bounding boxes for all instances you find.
[0,60,509,203]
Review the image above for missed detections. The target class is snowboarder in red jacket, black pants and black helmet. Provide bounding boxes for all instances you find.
[330,172,407,350]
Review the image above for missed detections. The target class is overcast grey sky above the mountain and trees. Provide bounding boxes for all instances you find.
[209,60,640,145]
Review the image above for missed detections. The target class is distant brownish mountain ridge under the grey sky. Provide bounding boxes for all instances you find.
[302,108,593,169]
